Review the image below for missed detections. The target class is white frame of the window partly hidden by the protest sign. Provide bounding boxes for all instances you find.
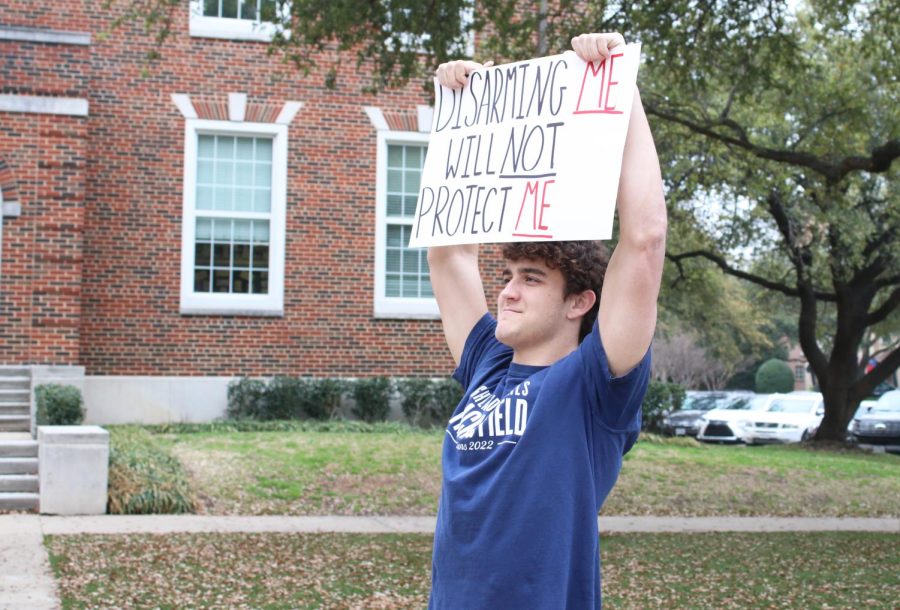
[374,130,440,320]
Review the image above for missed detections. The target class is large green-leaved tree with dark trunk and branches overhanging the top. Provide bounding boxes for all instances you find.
[119,0,900,440]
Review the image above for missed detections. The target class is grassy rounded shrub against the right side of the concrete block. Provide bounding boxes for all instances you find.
[107,426,197,515]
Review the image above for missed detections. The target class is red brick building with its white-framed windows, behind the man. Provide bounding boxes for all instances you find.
[0,0,492,423]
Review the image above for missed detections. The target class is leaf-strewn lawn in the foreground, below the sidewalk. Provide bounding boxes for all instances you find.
[46,532,900,610]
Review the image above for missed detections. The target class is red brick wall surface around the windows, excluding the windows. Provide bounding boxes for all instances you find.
[0,0,506,376]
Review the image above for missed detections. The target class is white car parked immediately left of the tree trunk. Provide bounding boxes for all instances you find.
[744,392,825,445]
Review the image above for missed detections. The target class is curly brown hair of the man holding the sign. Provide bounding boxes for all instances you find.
[502,241,609,341]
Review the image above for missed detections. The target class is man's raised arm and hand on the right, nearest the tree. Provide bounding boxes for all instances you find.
[572,34,666,375]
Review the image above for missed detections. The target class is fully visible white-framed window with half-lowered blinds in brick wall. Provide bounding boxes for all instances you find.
[181,120,287,315]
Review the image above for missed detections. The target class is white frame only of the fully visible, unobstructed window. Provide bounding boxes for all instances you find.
[180,119,288,316]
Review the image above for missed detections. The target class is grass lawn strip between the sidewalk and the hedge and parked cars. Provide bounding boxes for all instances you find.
[158,431,900,517]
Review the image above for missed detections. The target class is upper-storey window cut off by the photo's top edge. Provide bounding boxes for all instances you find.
[190,0,288,42]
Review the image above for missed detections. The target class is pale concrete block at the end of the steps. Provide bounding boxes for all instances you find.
[38,426,109,515]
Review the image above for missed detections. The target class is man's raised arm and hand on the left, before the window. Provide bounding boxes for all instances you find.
[428,61,489,364]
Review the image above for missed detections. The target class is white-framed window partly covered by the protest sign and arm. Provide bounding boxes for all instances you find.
[375,131,438,318]
